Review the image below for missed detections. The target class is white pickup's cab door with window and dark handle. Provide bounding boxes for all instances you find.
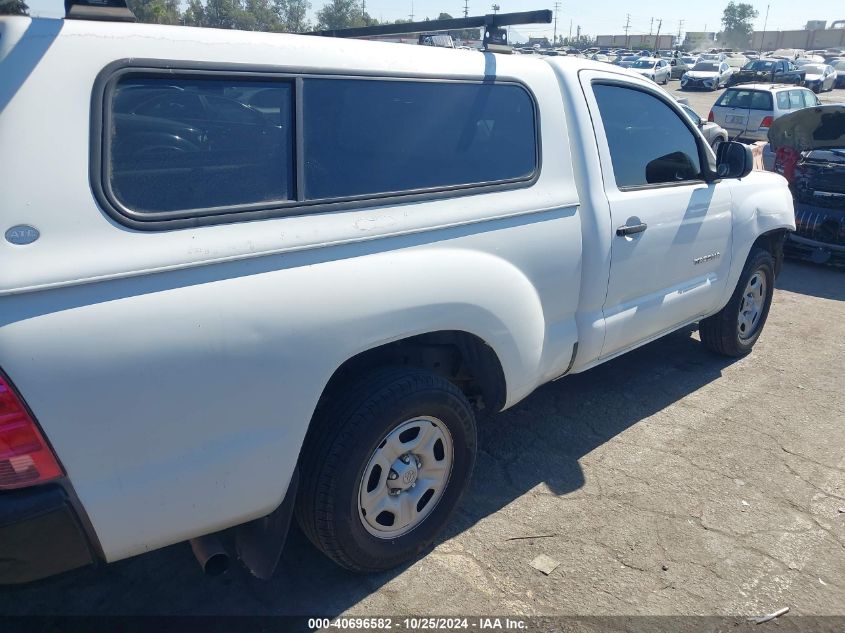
[582,73,732,358]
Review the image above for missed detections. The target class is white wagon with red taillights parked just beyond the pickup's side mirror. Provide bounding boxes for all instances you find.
[707,84,821,141]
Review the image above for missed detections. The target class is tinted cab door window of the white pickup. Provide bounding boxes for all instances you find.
[593,84,702,189]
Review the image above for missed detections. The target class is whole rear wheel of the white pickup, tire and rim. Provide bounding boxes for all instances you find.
[296,368,476,572]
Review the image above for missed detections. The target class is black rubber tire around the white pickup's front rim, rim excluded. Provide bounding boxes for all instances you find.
[698,248,775,358]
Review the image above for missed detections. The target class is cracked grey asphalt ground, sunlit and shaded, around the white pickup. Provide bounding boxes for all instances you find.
[0,262,845,617]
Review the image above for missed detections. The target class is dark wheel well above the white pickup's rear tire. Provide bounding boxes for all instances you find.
[318,330,506,417]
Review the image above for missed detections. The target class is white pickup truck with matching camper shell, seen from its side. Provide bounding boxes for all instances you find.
[0,11,794,583]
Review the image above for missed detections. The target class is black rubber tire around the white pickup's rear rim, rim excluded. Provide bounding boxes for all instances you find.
[296,368,476,572]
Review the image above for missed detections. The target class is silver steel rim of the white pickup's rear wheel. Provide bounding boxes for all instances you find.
[358,416,454,539]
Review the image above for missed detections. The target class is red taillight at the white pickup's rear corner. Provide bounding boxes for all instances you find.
[0,376,62,490]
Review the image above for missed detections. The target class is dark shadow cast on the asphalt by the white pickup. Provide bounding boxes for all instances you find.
[0,328,731,617]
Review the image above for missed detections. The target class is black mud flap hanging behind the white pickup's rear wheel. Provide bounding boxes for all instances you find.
[235,467,299,580]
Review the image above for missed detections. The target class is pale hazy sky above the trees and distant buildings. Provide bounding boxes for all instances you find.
[28,0,845,36]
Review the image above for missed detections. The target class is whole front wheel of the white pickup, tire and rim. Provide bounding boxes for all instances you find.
[698,248,775,357]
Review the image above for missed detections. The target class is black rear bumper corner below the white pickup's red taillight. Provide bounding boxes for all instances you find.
[0,484,95,585]
